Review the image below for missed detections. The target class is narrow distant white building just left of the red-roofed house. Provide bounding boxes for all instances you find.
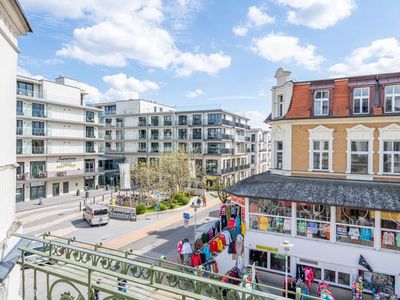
[250,128,271,175]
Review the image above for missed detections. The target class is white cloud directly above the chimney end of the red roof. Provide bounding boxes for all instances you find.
[252,33,325,70]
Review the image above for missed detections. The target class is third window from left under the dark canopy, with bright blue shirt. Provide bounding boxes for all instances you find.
[336,207,375,247]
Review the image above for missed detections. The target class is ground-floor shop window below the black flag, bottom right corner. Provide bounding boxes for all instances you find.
[358,270,395,296]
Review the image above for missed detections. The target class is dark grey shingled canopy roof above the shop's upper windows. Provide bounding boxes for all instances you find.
[226,172,400,212]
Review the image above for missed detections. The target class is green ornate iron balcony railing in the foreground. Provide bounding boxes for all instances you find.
[15,234,315,300]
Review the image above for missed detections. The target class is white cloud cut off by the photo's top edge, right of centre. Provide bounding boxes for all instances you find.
[277,0,356,29]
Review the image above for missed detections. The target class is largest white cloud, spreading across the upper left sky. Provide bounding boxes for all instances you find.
[26,0,230,76]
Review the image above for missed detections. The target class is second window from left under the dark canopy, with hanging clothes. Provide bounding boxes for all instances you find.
[297,203,331,240]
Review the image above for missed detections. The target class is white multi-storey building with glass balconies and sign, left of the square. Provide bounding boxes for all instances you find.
[16,76,104,202]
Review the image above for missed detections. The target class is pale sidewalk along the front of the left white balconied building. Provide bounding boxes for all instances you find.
[16,189,114,213]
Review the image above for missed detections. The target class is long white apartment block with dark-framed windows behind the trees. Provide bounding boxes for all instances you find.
[97,100,250,186]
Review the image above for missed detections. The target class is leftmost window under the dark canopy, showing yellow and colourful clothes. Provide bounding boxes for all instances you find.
[249,198,292,234]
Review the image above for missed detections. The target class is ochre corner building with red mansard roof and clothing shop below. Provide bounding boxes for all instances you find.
[229,69,400,299]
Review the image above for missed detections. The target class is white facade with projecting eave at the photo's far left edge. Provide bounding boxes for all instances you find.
[0,0,31,299]
